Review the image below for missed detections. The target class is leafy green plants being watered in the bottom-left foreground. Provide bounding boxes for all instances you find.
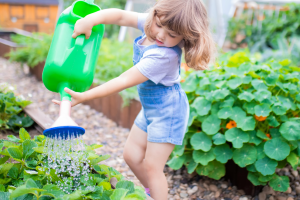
[0,128,146,200]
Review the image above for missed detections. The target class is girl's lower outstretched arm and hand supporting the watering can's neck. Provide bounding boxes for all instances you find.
[52,66,148,106]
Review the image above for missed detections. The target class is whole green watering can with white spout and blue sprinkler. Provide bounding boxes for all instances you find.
[43,0,104,138]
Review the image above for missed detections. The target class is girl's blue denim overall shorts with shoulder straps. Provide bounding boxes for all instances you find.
[133,36,189,145]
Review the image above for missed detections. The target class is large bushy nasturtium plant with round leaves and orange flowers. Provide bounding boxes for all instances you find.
[168,52,300,191]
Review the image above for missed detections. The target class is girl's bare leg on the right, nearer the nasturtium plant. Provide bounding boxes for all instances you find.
[144,142,175,200]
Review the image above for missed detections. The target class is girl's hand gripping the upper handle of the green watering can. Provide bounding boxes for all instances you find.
[72,18,93,39]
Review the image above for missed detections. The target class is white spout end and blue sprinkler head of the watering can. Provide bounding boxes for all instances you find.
[43,100,85,139]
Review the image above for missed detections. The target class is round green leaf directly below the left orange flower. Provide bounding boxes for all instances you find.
[225,128,249,148]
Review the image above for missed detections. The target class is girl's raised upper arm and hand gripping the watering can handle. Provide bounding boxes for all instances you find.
[72,8,138,39]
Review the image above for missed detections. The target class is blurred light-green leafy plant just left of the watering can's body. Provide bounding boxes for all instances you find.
[7,33,52,67]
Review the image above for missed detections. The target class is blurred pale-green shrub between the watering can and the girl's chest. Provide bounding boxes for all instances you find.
[94,38,138,105]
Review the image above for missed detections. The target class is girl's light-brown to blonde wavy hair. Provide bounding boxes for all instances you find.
[144,0,215,70]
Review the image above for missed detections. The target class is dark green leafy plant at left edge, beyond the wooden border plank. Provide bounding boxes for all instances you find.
[0,83,33,132]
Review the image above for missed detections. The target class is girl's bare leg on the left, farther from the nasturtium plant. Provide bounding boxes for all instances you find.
[123,124,148,188]
